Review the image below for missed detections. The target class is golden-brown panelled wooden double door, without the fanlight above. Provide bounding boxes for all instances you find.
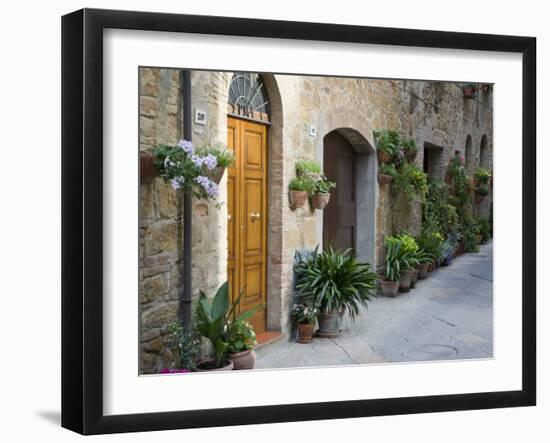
[227,117,267,333]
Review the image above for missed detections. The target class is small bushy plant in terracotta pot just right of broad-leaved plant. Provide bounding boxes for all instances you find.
[227,319,256,370]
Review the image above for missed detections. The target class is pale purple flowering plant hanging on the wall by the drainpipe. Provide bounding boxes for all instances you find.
[154,140,234,200]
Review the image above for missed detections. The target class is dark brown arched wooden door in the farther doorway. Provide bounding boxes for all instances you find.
[323,131,357,250]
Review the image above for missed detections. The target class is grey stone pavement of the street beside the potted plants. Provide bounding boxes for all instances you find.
[256,242,493,369]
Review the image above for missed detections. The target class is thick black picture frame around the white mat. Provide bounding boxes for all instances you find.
[62,9,536,434]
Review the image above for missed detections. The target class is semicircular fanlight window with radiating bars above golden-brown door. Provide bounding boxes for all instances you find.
[228,72,270,122]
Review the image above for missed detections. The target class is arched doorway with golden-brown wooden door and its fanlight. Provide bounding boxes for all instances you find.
[227,72,270,333]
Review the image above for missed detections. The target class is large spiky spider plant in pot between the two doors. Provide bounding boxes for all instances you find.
[294,248,377,337]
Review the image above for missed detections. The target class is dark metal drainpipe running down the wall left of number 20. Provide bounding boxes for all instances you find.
[180,70,193,328]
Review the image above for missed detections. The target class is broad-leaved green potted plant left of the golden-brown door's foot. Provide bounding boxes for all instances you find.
[195,282,260,371]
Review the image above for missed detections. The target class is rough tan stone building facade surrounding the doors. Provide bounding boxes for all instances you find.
[139,68,493,373]
